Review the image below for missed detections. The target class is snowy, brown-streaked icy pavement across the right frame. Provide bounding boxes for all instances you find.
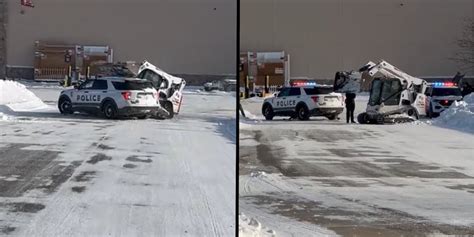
[239,98,474,237]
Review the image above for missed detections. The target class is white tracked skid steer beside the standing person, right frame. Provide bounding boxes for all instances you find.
[334,60,428,124]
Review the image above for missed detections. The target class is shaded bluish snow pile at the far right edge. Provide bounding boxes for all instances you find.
[432,93,474,133]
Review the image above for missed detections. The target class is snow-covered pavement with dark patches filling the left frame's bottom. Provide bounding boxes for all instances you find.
[0,85,236,236]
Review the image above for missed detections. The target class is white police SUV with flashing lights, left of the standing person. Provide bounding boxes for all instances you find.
[262,87,344,120]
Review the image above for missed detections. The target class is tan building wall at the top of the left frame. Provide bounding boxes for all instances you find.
[7,0,237,75]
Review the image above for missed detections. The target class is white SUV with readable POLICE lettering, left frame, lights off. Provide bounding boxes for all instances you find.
[58,77,164,119]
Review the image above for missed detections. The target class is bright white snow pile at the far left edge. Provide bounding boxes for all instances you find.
[0,80,48,111]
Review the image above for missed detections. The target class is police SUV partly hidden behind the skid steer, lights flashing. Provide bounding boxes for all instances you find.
[425,82,462,118]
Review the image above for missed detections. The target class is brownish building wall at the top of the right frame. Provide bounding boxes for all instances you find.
[240,0,474,78]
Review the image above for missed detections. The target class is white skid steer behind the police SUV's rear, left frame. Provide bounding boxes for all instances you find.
[137,61,186,118]
